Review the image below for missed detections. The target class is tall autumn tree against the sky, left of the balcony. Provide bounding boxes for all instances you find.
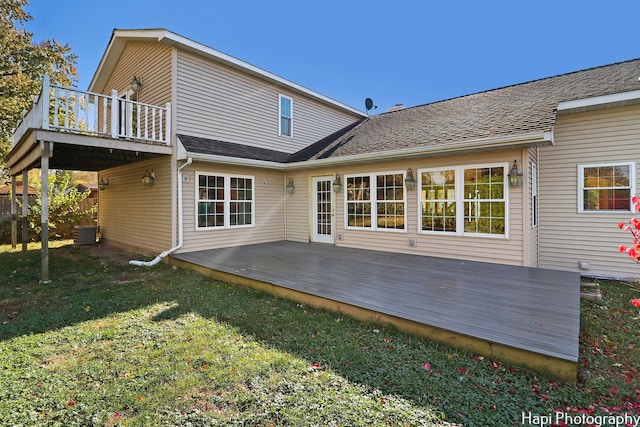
[0,0,77,177]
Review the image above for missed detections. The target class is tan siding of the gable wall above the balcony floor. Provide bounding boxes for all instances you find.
[102,42,172,107]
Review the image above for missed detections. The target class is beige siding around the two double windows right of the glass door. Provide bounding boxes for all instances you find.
[294,150,529,265]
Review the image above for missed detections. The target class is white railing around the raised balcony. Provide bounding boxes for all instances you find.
[13,75,171,146]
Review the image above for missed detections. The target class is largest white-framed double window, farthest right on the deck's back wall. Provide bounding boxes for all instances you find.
[418,164,508,236]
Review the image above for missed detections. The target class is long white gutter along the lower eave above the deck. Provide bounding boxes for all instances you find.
[188,131,553,170]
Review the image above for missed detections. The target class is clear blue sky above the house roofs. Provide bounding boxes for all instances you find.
[27,0,640,113]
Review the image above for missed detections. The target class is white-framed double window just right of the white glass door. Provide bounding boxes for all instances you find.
[345,172,406,230]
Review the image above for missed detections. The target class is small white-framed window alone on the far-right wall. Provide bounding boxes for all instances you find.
[578,163,635,212]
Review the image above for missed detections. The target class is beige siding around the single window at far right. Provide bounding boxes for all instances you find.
[538,106,640,278]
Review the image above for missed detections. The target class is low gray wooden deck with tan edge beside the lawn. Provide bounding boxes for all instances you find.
[170,242,580,382]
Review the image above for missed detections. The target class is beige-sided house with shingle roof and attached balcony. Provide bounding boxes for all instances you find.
[7,29,640,278]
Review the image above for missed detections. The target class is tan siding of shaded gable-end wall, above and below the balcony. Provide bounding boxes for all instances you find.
[96,41,176,254]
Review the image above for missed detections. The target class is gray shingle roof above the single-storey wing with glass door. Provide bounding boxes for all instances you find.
[300,59,640,160]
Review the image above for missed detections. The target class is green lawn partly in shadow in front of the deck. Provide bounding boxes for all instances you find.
[0,241,640,427]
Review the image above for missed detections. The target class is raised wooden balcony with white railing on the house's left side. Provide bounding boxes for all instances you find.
[7,76,172,175]
